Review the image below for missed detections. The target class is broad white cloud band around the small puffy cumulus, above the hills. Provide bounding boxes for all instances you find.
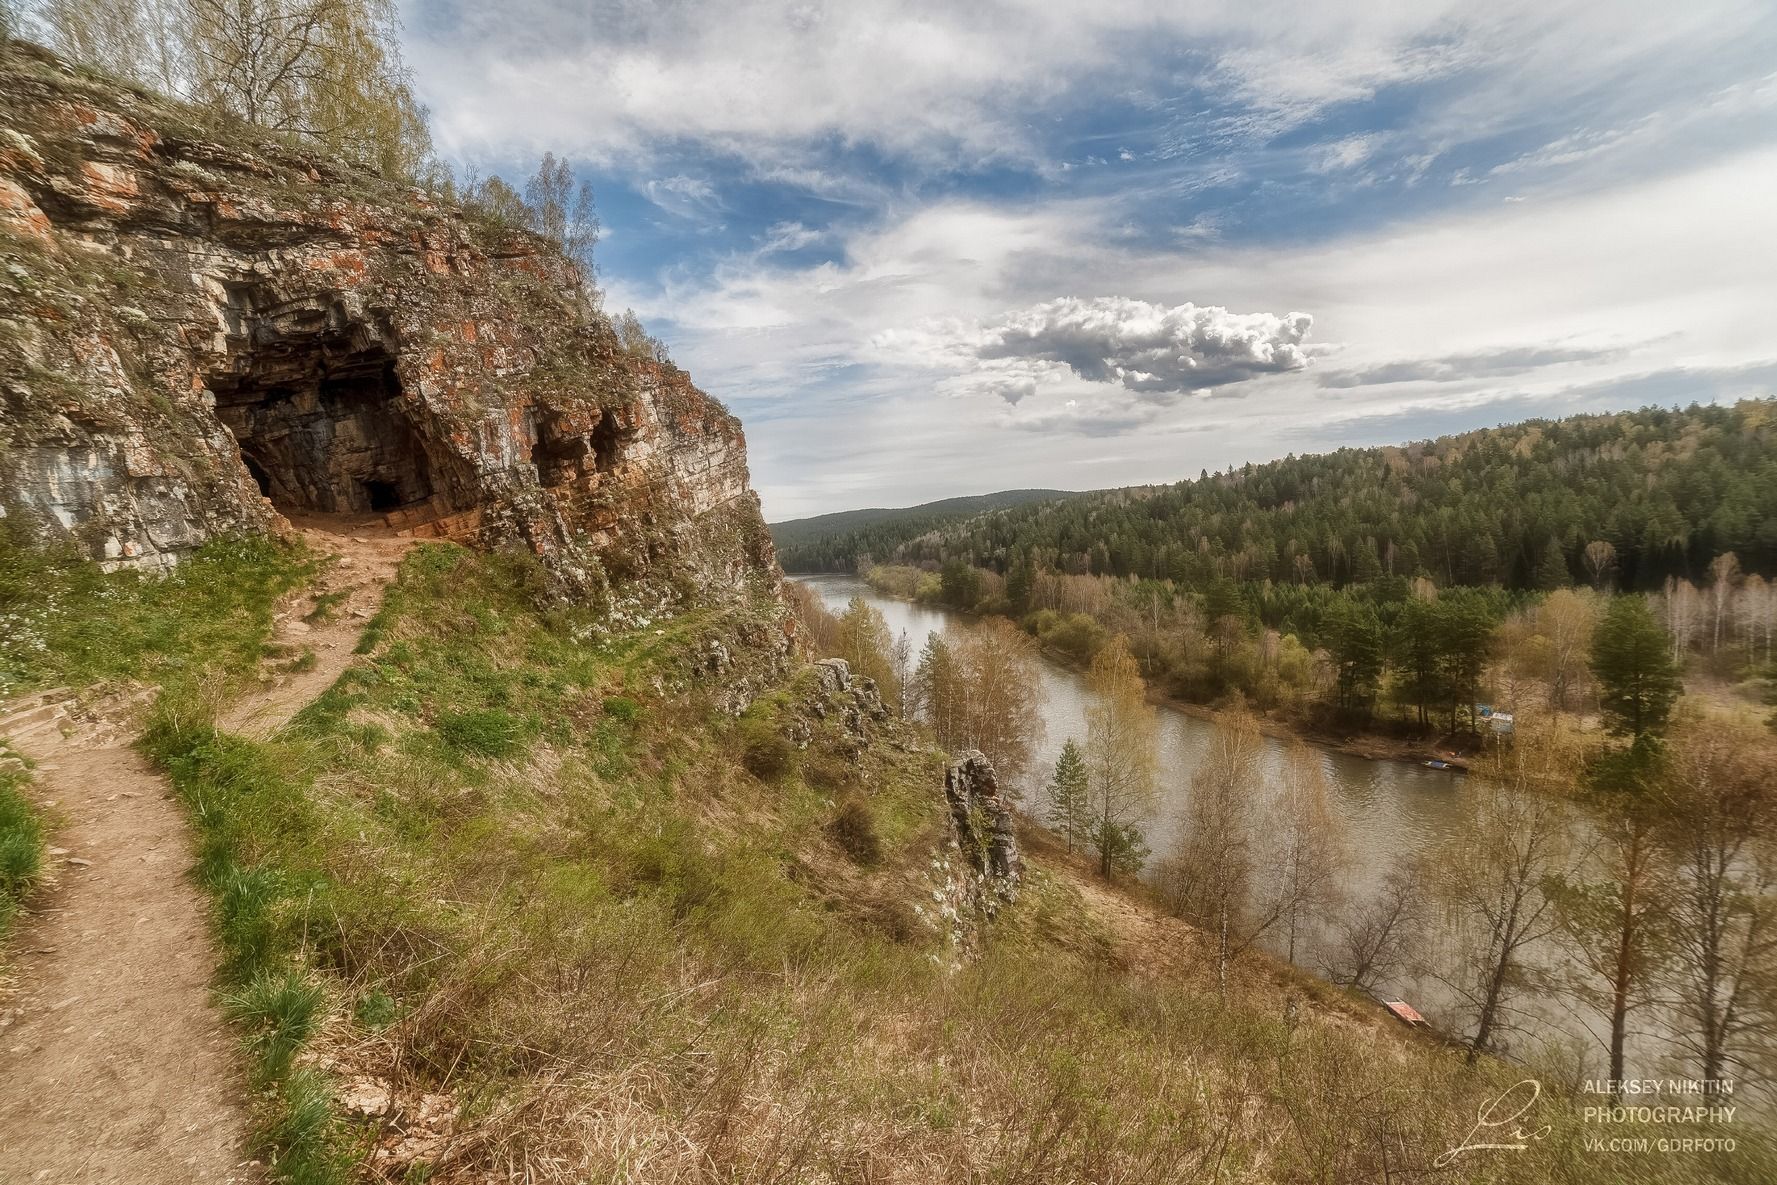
[643,137,1777,517]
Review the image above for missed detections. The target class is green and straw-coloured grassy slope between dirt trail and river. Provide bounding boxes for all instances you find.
[131,547,1770,1181]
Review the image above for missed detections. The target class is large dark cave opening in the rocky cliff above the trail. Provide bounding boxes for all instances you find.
[210,350,435,515]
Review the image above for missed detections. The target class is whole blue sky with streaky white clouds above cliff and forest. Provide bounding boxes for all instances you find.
[402,0,1777,521]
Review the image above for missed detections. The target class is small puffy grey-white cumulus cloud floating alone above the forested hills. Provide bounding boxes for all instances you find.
[935,297,1313,403]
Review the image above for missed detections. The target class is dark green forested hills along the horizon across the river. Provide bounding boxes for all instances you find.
[773,400,1777,592]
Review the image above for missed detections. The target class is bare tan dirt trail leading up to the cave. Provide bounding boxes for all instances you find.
[0,522,410,1185]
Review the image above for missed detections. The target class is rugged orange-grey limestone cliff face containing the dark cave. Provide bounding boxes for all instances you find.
[0,46,775,600]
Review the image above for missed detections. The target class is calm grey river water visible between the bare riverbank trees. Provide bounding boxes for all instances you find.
[794,574,1654,1077]
